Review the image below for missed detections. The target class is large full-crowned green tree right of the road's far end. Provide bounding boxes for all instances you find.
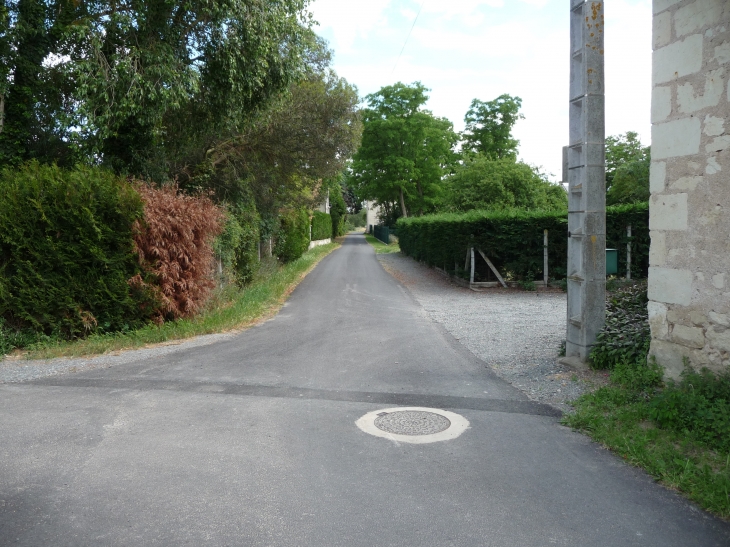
[349,82,457,217]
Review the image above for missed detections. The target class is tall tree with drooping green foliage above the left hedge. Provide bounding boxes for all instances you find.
[0,0,311,178]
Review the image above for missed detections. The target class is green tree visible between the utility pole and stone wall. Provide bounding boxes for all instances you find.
[606,131,651,205]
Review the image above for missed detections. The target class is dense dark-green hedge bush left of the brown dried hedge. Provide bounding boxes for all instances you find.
[0,162,151,338]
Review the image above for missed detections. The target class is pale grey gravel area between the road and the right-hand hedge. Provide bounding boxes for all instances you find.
[378,253,606,412]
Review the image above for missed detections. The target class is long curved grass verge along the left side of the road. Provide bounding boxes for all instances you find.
[11,243,340,359]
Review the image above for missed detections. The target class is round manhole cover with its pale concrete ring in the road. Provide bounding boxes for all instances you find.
[355,407,469,444]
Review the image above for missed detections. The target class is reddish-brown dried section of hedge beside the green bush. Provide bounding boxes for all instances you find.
[130,183,224,323]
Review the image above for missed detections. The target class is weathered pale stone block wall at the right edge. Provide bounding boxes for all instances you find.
[649,0,730,377]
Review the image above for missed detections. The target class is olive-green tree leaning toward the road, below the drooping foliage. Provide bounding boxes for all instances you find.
[181,42,362,215]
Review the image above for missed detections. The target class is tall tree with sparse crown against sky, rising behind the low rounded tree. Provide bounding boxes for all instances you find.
[462,94,524,159]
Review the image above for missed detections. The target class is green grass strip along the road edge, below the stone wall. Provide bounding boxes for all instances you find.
[563,386,730,519]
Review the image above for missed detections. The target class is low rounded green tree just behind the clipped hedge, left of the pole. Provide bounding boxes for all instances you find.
[448,154,568,211]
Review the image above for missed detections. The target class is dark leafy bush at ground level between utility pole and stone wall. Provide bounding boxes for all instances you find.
[590,281,651,369]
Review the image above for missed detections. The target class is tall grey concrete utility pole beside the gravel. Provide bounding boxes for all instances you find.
[565,0,606,362]
